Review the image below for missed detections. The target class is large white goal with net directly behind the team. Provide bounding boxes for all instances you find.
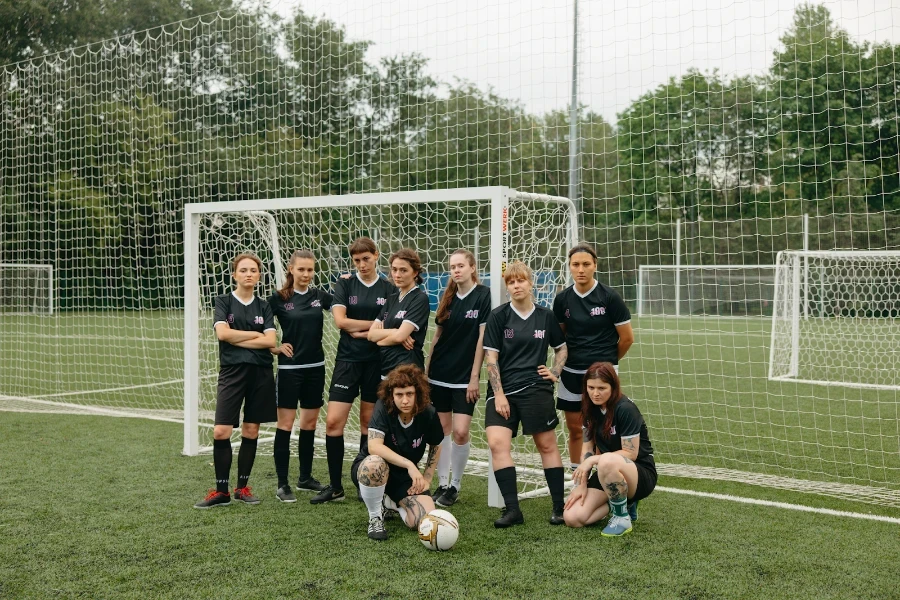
[183,187,577,504]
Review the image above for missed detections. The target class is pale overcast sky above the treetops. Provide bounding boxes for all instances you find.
[271,0,900,121]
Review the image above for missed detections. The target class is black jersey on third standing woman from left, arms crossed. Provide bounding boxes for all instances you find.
[331,274,397,362]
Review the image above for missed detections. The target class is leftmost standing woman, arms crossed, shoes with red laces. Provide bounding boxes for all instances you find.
[194,254,277,509]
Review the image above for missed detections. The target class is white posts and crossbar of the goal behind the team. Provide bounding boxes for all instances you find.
[182,186,578,506]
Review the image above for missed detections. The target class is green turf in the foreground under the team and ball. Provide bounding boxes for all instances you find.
[0,413,900,600]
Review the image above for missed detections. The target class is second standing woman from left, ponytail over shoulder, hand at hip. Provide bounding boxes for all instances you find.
[269,250,332,502]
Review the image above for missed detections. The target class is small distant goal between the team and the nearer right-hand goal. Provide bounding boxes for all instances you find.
[637,265,775,317]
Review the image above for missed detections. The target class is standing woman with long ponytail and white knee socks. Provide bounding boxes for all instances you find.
[426,250,491,506]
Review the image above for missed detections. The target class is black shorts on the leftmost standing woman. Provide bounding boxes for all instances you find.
[216,364,278,427]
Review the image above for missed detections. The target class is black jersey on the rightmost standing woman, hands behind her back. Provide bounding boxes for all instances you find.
[553,281,631,373]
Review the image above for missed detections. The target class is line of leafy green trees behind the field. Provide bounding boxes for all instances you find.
[0,0,900,308]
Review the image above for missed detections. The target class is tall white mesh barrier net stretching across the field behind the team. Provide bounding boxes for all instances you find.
[0,0,900,506]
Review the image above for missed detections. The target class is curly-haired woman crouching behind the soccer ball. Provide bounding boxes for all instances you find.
[350,364,444,540]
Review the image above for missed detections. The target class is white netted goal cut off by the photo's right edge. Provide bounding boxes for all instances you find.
[769,251,900,390]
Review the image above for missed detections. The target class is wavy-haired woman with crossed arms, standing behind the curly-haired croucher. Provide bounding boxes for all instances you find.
[368,248,431,379]
